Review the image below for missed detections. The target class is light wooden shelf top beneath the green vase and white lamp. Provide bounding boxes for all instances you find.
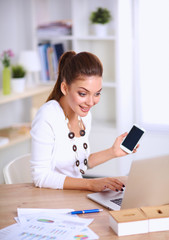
[0,83,53,104]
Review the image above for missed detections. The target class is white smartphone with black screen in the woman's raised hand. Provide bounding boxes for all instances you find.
[120,124,145,153]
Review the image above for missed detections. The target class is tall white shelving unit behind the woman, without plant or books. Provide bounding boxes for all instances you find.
[32,0,133,176]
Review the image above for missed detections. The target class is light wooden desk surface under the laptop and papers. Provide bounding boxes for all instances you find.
[0,184,169,240]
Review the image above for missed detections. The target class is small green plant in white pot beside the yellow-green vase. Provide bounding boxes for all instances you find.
[11,65,26,93]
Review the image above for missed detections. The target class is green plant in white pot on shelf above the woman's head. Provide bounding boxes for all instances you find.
[90,7,112,36]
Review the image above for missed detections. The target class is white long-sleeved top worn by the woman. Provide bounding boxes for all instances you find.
[31,100,91,189]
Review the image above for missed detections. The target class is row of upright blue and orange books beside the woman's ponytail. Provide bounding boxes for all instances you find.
[38,42,64,82]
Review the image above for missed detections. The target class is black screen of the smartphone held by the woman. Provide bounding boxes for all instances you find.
[122,126,144,151]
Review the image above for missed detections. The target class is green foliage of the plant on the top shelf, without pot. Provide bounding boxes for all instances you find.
[90,7,112,24]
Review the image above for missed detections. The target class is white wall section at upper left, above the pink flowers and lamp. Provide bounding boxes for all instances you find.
[0,0,32,69]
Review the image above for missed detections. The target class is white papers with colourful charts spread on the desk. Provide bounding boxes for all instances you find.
[0,209,99,240]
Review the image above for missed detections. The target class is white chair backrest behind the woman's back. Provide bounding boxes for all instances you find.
[3,153,33,184]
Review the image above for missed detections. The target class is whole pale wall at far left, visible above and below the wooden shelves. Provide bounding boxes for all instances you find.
[0,0,32,183]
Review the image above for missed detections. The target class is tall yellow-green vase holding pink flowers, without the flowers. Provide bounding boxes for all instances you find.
[2,67,11,95]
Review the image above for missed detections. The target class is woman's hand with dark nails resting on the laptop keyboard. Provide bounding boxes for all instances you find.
[88,177,125,192]
